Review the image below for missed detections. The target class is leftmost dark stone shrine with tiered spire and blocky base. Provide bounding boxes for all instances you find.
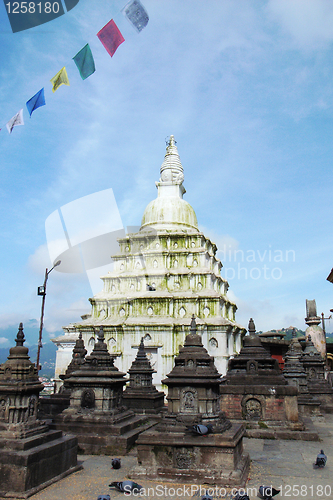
[0,323,81,498]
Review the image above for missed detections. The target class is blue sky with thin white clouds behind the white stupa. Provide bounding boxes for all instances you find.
[0,0,333,347]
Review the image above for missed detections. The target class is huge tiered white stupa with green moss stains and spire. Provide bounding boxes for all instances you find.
[54,136,245,390]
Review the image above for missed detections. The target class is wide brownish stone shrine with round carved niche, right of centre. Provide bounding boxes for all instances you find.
[220,318,305,437]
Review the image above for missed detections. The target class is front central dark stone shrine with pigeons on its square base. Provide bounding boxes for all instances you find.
[130,318,249,486]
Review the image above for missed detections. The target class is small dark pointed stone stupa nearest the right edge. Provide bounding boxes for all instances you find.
[301,335,333,413]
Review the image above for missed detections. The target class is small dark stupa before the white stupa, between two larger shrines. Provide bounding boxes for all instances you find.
[123,337,164,414]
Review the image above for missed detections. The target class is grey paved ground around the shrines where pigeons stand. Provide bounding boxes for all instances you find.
[30,414,333,500]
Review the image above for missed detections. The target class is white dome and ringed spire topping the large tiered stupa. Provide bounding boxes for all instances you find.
[141,135,199,231]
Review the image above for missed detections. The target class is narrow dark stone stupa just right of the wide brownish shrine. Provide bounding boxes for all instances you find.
[283,329,320,415]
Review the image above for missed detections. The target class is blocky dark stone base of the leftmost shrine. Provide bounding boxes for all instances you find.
[0,430,82,499]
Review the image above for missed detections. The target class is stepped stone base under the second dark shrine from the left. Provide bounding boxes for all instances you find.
[52,410,156,455]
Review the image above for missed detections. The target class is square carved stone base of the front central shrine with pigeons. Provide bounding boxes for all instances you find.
[129,424,250,487]
